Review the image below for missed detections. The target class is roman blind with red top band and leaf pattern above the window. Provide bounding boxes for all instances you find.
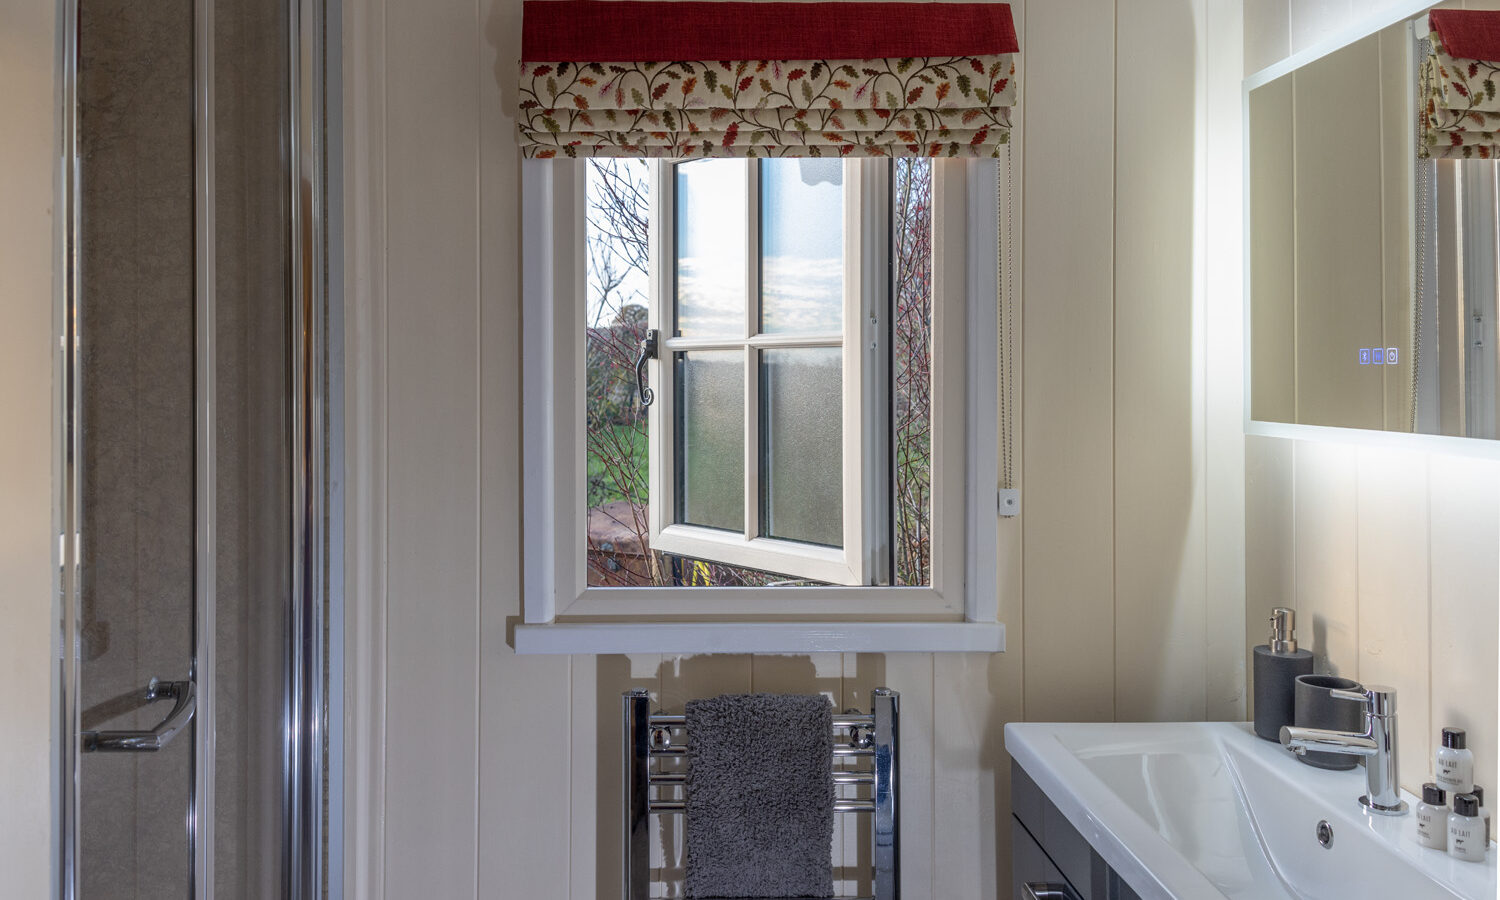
[518,0,1020,158]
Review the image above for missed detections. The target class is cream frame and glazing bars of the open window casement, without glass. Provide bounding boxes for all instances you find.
[647,159,891,587]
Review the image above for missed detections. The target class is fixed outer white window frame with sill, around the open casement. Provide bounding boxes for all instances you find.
[515,159,1005,653]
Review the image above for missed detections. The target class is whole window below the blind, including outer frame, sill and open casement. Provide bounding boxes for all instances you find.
[516,159,1004,653]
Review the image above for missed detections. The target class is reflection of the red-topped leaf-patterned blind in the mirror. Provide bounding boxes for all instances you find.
[1418,9,1500,159]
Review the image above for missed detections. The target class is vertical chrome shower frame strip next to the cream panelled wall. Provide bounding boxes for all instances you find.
[286,0,344,899]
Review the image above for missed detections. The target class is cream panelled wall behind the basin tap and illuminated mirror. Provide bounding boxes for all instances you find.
[1245,0,1500,791]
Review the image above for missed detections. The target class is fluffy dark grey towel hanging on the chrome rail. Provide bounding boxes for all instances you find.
[684,695,834,900]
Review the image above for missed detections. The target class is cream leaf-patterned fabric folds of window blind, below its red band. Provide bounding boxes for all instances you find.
[519,0,1017,158]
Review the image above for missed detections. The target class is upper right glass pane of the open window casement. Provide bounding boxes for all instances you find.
[761,159,843,335]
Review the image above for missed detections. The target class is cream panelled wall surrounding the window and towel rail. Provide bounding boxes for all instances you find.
[345,0,1244,899]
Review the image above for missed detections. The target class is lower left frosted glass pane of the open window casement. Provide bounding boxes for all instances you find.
[677,350,746,531]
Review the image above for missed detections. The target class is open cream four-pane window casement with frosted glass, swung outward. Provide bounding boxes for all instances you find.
[650,159,893,585]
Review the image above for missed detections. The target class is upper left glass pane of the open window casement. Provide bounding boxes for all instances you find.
[675,159,750,338]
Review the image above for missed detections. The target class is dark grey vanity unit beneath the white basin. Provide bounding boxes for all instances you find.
[1011,762,1139,900]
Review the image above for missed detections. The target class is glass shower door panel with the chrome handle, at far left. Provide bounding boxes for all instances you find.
[75,0,198,900]
